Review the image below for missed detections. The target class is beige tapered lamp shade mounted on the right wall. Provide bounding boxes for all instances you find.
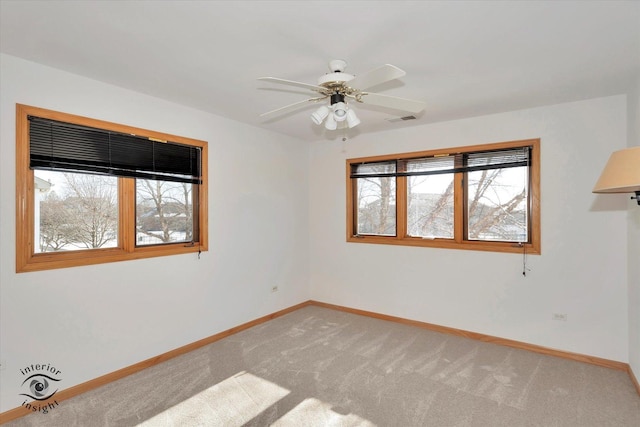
[593,146,640,193]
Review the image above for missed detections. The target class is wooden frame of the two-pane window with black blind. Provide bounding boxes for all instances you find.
[16,104,208,273]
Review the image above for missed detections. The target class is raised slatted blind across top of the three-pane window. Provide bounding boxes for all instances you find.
[351,147,531,178]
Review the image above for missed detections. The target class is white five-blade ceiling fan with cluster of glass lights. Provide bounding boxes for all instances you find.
[258,59,425,130]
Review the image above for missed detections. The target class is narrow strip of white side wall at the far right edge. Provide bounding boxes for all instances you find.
[625,77,640,381]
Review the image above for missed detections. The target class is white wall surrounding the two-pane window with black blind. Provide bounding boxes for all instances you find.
[0,55,309,412]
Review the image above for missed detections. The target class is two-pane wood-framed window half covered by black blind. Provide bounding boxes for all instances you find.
[16,105,207,272]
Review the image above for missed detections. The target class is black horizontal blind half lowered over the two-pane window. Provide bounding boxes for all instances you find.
[29,116,201,184]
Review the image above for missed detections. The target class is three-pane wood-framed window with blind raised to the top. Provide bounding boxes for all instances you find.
[347,139,540,254]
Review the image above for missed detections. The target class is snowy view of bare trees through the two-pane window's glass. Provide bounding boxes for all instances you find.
[37,171,193,252]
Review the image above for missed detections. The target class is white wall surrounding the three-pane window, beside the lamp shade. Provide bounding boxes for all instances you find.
[309,95,629,362]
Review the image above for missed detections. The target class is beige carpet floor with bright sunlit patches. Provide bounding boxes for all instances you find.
[7,306,640,427]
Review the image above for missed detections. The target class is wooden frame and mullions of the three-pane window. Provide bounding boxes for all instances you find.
[346,139,541,255]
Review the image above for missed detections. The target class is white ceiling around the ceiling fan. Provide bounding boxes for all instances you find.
[0,0,640,141]
